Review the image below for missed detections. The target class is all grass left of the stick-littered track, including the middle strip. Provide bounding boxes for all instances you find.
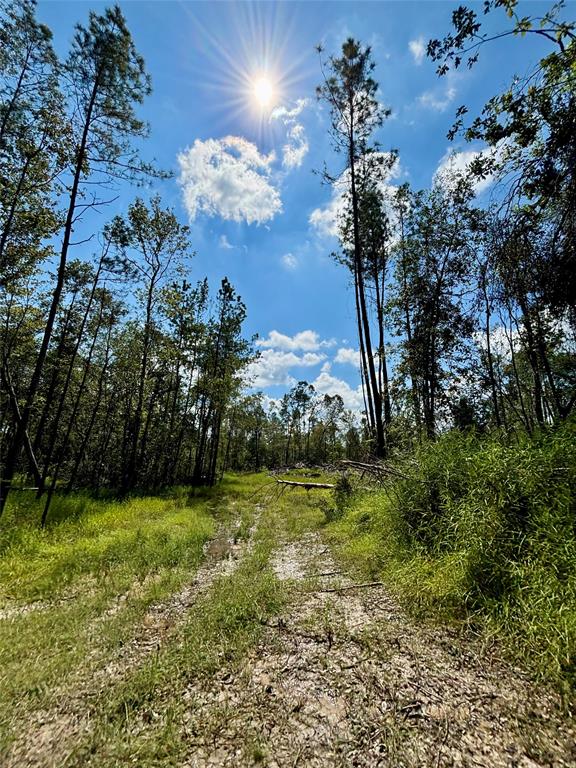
[0,475,332,766]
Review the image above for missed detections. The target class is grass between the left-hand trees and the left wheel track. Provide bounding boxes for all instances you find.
[0,486,216,749]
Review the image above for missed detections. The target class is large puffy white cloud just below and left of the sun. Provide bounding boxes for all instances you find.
[178,136,282,224]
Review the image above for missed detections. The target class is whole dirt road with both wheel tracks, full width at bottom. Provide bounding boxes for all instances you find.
[6,504,576,768]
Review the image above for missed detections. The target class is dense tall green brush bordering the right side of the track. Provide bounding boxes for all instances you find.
[329,424,576,691]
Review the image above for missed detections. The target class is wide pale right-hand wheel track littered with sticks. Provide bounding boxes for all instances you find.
[185,534,576,768]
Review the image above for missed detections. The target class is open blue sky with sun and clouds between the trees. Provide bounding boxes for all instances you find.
[38,0,548,410]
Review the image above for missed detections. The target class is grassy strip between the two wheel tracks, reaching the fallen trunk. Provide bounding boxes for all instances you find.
[61,475,323,766]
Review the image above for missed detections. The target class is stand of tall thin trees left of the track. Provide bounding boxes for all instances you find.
[0,0,253,521]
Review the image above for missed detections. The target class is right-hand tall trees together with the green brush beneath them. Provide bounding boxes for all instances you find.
[319,0,576,695]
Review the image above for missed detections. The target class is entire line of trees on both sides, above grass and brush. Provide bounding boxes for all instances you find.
[0,0,576,518]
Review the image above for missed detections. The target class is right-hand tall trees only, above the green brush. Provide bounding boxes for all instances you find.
[317,0,576,457]
